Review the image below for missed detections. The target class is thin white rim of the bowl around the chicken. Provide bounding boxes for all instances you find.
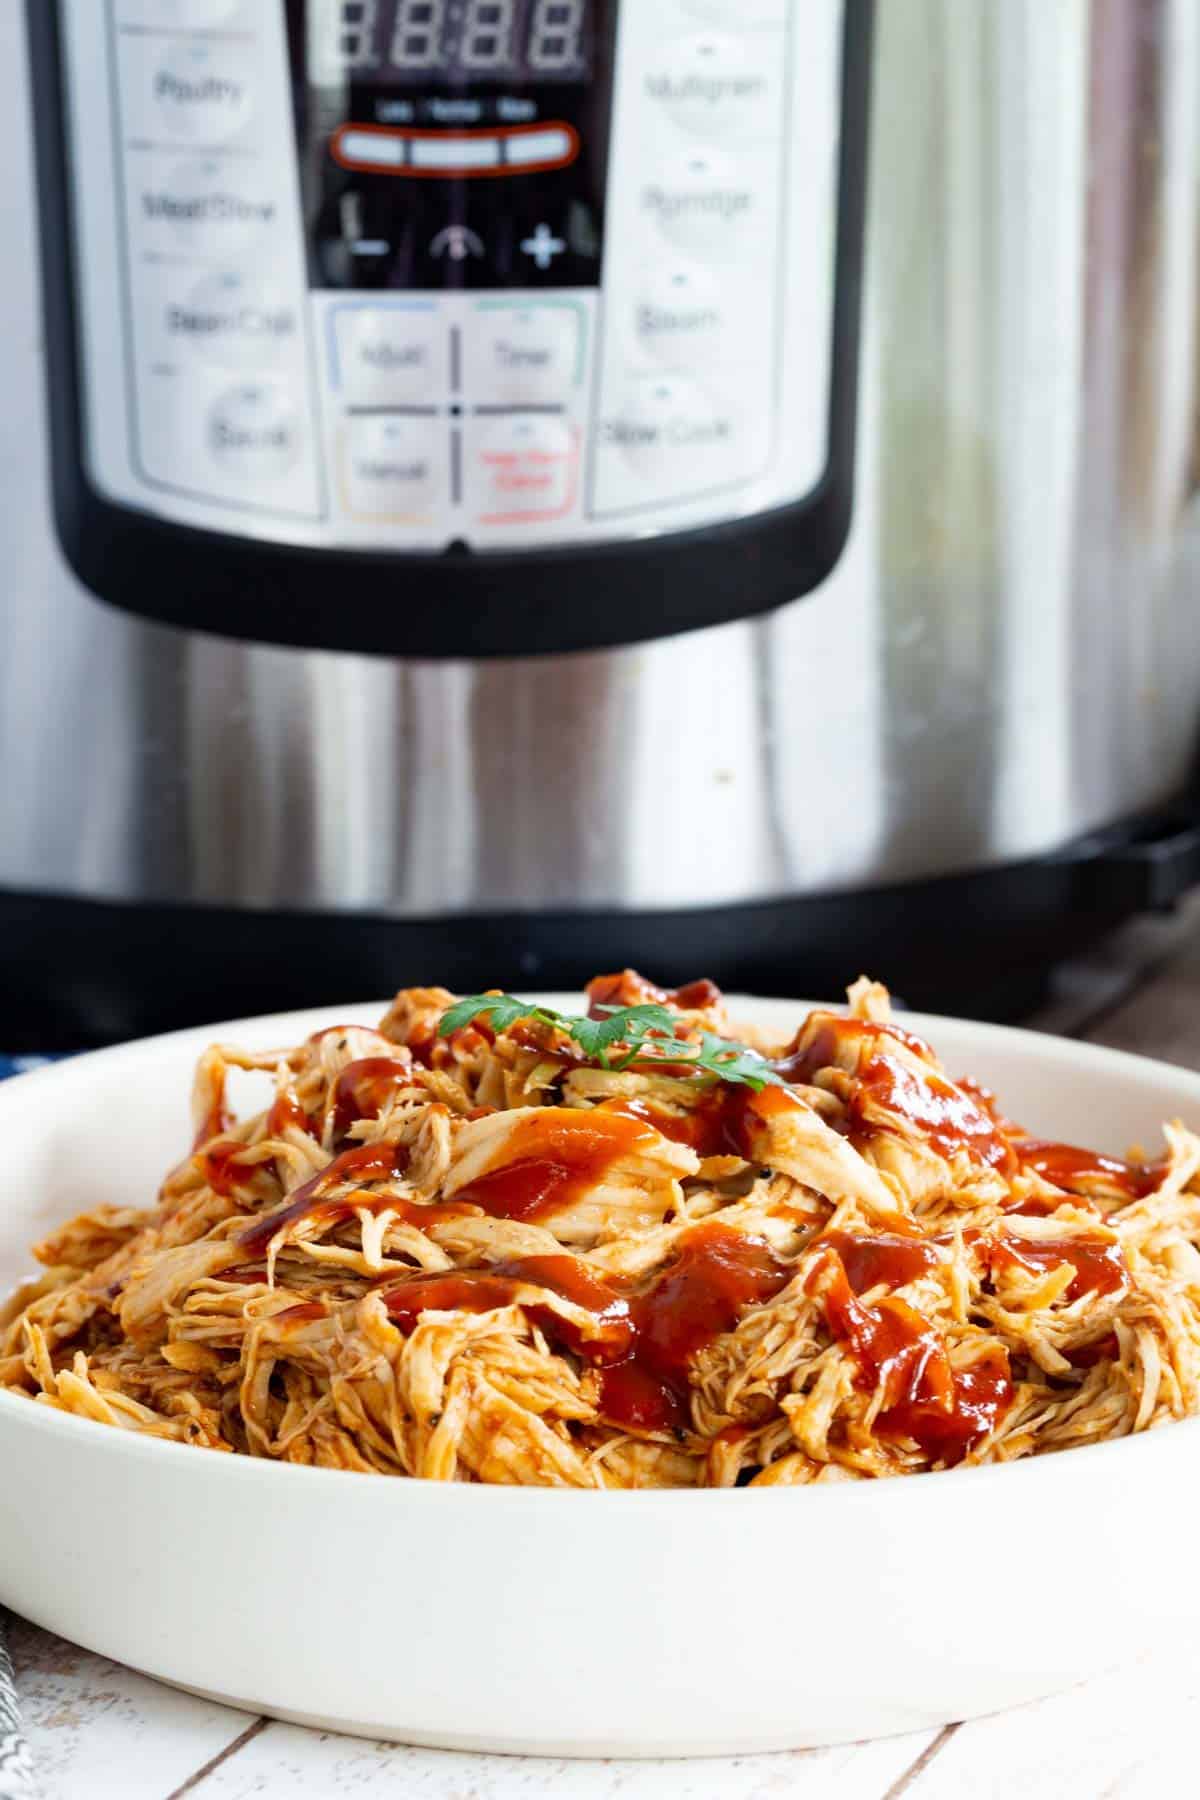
[0,990,1200,1508]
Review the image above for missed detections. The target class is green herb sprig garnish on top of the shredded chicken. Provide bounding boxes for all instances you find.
[437,994,786,1094]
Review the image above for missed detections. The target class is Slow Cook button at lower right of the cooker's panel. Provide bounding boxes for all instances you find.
[599,374,745,499]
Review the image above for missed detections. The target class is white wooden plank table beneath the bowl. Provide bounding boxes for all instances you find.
[9,905,1200,1800]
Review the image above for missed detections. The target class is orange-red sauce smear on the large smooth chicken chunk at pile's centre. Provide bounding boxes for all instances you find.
[457,1107,657,1220]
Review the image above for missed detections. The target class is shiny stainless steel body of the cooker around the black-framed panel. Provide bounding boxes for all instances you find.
[0,0,1200,1044]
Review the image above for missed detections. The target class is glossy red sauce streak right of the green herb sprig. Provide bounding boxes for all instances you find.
[774,1015,1016,1172]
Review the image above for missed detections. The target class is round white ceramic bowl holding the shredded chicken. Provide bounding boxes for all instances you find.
[0,1001,1200,1757]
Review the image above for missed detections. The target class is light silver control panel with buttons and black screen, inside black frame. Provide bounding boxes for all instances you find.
[59,0,844,553]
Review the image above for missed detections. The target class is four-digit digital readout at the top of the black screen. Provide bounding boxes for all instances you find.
[309,0,596,86]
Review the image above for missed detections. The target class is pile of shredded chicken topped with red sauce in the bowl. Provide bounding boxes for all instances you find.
[0,970,1200,1487]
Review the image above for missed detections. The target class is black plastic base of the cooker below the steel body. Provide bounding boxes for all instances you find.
[0,814,1200,1051]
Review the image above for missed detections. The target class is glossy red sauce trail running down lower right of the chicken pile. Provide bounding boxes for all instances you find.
[810,1251,1013,1463]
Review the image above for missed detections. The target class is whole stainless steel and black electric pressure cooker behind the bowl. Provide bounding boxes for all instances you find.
[0,0,1200,1048]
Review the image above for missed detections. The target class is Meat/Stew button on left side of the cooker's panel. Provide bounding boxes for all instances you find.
[128,157,279,256]
